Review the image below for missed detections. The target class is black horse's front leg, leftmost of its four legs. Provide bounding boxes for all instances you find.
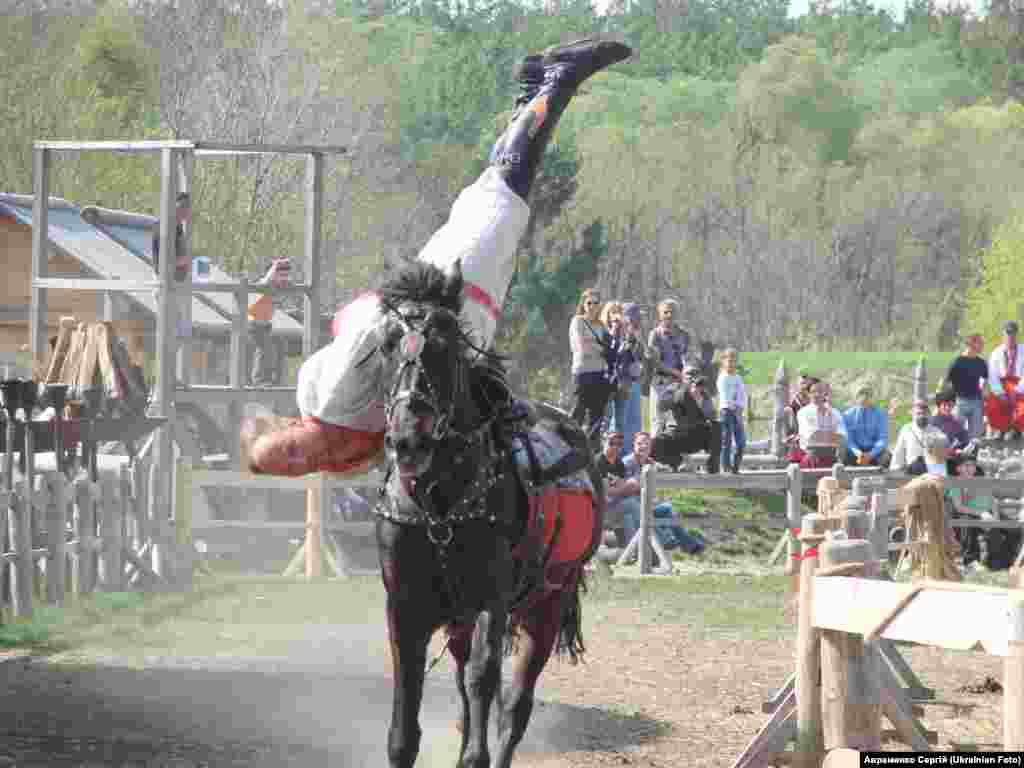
[387,596,431,768]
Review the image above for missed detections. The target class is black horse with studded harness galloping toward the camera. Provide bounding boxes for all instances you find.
[375,264,604,768]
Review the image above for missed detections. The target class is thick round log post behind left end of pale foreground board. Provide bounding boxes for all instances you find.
[818,539,882,750]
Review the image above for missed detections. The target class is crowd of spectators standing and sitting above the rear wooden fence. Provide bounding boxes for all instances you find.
[569,289,1024,530]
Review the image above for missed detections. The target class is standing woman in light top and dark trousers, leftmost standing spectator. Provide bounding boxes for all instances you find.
[569,289,611,445]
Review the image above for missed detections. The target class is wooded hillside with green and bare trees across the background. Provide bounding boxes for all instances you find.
[6,0,1024,397]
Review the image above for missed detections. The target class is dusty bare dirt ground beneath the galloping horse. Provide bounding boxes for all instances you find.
[0,577,1002,768]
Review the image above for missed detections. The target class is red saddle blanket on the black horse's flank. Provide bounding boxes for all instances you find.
[513,487,597,565]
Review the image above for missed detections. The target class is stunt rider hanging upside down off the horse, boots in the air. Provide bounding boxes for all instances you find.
[242,39,632,476]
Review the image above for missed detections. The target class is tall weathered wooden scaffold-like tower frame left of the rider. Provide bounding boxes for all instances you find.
[29,140,345,574]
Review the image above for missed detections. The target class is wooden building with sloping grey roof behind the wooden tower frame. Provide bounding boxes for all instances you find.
[0,194,302,384]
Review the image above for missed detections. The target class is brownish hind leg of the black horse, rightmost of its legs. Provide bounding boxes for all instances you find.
[495,592,561,768]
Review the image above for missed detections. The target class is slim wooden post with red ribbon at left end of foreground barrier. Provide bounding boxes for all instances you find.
[795,514,827,768]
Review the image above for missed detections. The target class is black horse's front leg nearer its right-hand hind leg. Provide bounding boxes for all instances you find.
[459,604,507,768]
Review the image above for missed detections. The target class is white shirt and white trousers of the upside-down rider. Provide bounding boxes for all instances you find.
[296,168,529,431]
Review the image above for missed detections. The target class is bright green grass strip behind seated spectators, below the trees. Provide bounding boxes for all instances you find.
[740,350,955,386]
